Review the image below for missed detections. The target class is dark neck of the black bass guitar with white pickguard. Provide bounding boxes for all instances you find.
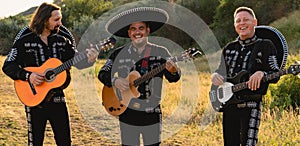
[232,70,287,93]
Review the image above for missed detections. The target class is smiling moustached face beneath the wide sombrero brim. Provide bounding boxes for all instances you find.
[128,22,150,48]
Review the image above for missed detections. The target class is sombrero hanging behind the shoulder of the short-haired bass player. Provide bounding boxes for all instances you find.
[255,26,288,69]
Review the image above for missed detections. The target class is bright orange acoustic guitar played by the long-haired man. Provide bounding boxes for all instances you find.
[14,37,116,107]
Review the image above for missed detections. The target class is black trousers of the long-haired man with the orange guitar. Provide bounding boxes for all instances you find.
[25,102,71,146]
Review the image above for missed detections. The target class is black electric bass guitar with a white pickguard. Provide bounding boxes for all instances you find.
[209,65,300,112]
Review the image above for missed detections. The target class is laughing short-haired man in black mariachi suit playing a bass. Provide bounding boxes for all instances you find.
[212,7,287,146]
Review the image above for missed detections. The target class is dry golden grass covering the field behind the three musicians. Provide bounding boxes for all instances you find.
[0,57,300,146]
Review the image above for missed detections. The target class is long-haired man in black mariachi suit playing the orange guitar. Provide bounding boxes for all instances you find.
[2,3,98,146]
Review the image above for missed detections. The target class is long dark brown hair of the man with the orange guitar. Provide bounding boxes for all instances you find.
[29,2,61,34]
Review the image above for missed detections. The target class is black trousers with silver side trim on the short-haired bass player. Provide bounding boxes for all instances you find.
[223,100,262,146]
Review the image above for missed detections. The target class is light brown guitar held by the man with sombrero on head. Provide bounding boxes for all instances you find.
[102,48,201,116]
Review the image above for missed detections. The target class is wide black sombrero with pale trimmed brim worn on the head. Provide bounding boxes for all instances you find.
[105,7,169,37]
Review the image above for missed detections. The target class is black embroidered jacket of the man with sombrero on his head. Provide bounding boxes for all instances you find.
[98,43,180,125]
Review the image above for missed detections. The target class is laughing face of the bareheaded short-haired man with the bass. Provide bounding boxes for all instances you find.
[234,11,257,40]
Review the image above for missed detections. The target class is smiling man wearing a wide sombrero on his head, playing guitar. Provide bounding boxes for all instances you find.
[98,7,180,145]
